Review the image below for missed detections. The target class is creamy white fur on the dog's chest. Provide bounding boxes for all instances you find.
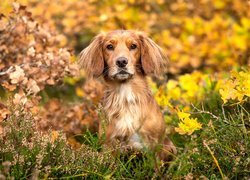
[105,84,141,138]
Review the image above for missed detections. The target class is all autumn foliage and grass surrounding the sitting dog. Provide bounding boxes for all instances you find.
[0,0,250,179]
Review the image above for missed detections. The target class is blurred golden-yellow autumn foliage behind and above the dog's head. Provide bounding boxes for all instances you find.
[0,0,250,74]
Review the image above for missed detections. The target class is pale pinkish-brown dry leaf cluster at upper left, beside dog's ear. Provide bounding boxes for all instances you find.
[0,4,76,116]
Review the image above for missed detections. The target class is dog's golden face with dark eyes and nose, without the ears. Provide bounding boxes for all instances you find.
[102,31,141,81]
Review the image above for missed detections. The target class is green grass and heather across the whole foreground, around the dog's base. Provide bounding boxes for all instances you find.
[0,101,250,179]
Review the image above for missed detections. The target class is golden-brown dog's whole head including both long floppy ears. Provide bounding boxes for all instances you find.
[78,30,167,82]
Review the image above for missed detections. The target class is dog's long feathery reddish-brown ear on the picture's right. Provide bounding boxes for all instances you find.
[139,32,168,76]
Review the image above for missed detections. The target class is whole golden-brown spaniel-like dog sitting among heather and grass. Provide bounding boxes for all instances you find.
[78,30,177,160]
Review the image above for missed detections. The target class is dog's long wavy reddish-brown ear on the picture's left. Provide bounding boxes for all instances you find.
[78,34,104,78]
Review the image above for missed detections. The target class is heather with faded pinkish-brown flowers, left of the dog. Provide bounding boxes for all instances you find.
[0,108,116,179]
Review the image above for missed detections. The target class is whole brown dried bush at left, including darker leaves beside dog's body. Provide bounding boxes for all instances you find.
[0,3,98,139]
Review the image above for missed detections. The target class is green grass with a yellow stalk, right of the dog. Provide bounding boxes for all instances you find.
[168,106,250,179]
